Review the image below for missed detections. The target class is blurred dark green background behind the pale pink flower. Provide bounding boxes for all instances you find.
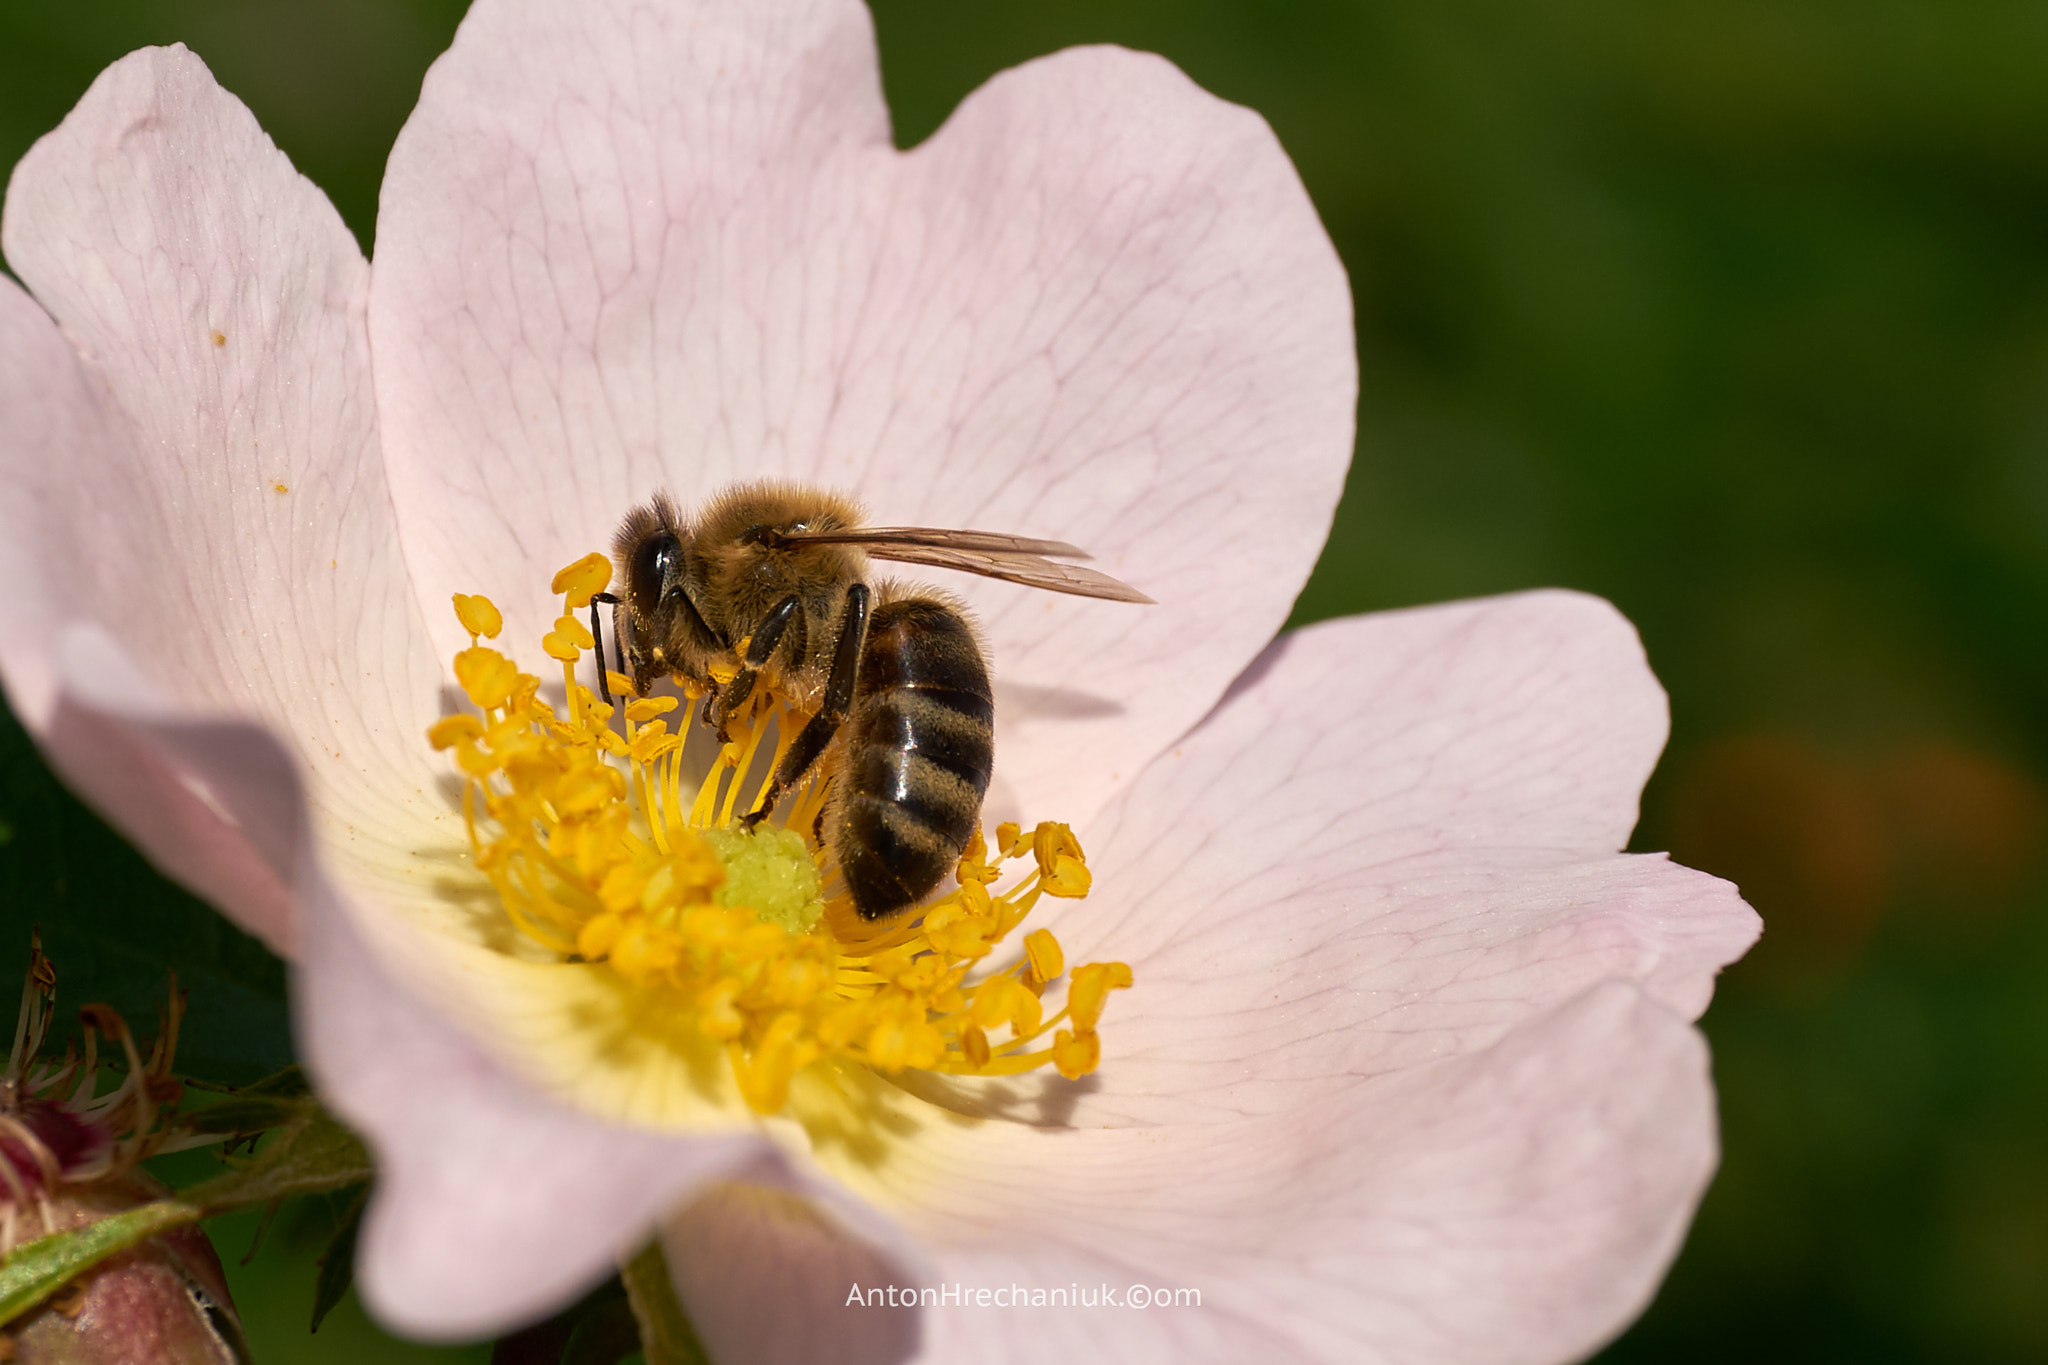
[0,0,2048,1363]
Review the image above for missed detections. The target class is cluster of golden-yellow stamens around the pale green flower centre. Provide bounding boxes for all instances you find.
[428,555,1130,1113]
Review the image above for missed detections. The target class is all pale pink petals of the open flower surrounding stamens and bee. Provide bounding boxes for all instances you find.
[0,0,1755,1363]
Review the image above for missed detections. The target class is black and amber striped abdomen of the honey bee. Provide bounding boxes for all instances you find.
[831,598,995,919]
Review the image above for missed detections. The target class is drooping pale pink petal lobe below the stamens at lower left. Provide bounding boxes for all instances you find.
[293,863,772,1338]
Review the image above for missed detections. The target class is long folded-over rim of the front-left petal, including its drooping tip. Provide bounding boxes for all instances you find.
[29,646,799,1336]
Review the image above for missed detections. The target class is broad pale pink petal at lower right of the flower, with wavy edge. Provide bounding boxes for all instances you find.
[712,593,1755,1361]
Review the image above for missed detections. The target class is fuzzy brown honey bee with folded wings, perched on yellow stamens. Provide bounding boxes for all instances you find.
[592,483,1151,921]
